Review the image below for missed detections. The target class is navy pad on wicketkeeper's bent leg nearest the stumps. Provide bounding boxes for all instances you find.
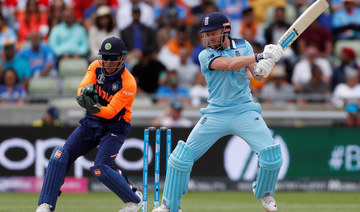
[90,164,140,203]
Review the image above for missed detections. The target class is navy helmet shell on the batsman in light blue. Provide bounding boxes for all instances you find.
[200,12,230,33]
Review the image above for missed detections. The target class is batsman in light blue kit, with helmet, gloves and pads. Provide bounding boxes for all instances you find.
[153,12,284,212]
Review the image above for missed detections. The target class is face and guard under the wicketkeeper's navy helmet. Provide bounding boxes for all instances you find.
[99,54,127,76]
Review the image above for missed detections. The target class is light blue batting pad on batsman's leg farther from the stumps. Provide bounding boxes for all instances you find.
[254,144,282,199]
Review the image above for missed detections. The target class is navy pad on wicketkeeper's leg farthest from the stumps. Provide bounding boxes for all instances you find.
[38,147,69,211]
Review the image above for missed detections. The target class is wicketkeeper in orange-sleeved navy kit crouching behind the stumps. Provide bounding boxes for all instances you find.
[36,37,142,212]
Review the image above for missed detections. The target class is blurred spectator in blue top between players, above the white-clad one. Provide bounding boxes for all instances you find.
[156,71,190,105]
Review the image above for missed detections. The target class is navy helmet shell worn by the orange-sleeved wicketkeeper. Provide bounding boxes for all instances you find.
[99,37,127,56]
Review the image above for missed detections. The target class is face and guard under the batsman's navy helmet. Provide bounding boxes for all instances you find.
[201,23,230,50]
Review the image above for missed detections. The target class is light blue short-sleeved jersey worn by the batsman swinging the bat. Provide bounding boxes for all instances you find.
[199,39,254,111]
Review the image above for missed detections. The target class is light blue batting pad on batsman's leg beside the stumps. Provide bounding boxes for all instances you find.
[163,141,194,212]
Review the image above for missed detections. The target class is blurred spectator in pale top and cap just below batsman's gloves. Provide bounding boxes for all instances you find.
[260,65,295,105]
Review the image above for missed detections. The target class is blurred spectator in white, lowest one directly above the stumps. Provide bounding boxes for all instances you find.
[151,101,193,128]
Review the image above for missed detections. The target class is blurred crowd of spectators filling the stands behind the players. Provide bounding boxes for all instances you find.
[0,0,360,126]
